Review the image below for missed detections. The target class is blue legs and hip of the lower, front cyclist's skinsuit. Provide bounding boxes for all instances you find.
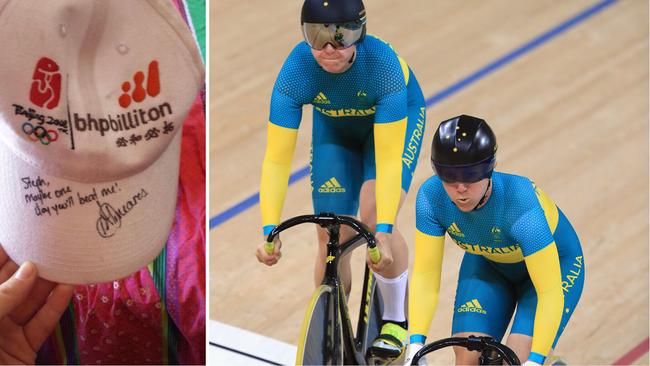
[451,217,584,348]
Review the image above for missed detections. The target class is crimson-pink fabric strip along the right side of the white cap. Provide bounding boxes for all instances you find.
[166,95,206,364]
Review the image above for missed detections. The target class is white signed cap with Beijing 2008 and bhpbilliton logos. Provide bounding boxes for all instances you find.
[0,0,204,284]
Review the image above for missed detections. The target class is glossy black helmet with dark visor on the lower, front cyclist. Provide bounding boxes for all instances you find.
[431,115,497,183]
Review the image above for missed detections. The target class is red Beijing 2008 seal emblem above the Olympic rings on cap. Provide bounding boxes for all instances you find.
[29,57,61,109]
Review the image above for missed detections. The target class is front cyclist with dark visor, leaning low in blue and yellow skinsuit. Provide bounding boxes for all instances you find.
[409,115,585,365]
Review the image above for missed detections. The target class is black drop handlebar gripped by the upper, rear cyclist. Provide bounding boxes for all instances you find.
[264,212,380,263]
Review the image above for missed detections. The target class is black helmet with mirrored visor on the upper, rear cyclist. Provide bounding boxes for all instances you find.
[300,0,366,50]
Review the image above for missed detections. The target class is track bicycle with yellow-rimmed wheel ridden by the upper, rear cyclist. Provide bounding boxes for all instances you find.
[265,213,385,365]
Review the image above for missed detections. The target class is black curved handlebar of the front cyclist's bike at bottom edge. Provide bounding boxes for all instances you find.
[411,336,521,365]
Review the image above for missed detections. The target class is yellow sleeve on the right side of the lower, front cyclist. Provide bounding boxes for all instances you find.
[524,242,564,357]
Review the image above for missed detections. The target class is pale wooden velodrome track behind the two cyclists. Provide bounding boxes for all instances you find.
[209,0,649,364]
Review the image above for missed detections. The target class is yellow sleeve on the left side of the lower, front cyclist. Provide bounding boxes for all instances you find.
[409,229,445,337]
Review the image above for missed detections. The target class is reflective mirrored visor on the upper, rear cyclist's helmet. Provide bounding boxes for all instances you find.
[302,19,365,50]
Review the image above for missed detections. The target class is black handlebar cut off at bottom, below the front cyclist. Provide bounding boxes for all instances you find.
[411,336,521,365]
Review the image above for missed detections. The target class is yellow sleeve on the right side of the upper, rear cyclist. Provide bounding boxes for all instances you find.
[374,118,406,232]
